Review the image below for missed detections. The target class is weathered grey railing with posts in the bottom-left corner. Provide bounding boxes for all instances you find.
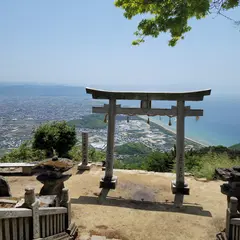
[0,188,71,240]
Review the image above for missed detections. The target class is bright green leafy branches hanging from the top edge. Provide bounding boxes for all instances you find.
[115,0,240,46]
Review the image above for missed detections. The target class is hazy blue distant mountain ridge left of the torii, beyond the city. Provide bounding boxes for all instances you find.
[0,83,87,97]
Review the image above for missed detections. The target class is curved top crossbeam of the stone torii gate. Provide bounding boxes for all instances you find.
[86,88,211,101]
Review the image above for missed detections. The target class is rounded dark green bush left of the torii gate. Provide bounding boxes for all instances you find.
[33,121,77,157]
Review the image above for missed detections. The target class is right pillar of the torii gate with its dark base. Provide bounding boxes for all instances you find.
[172,101,189,207]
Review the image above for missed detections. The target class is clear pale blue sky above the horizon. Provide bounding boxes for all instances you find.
[0,0,240,92]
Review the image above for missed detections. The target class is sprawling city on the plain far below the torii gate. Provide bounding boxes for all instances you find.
[0,85,201,155]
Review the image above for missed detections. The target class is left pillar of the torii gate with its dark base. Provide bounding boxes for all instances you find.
[100,99,117,189]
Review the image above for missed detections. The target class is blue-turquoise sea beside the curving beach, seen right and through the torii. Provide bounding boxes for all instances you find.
[113,90,240,147]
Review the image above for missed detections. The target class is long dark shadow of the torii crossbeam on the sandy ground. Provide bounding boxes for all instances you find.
[71,189,212,217]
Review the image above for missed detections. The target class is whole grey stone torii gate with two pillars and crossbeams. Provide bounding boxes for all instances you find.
[86,88,211,204]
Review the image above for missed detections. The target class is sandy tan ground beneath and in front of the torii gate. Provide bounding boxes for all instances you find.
[6,166,227,240]
